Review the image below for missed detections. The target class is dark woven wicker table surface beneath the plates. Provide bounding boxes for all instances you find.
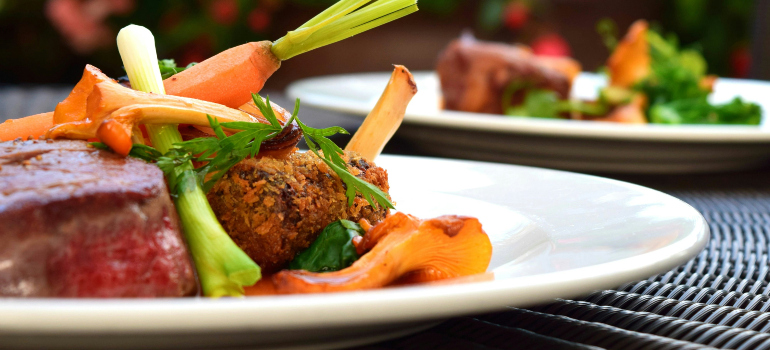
[6,87,770,350]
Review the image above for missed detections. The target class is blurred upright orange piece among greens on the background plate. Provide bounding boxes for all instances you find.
[607,20,651,88]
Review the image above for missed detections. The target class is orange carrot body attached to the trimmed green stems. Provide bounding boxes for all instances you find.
[163,41,281,108]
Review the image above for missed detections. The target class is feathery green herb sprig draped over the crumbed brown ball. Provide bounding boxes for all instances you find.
[108,94,395,209]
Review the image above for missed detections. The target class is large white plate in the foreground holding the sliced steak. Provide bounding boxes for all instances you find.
[0,156,709,348]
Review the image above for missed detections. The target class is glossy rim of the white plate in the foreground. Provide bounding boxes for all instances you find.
[0,155,709,337]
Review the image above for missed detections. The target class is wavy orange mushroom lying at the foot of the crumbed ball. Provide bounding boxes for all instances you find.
[246,213,492,295]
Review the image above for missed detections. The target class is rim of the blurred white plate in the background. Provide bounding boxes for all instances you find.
[285,71,770,144]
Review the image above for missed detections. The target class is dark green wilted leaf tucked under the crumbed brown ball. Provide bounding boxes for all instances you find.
[289,220,365,272]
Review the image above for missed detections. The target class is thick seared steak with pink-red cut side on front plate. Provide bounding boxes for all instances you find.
[0,140,197,297]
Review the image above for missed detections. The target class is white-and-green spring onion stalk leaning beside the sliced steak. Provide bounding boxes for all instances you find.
[115,25,261,297]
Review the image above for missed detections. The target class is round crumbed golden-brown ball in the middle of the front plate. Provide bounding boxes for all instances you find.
[208,152,389,273]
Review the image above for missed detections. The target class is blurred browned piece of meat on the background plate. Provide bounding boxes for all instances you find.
[436,37,580,114]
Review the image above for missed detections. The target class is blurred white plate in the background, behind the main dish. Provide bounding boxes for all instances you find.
[287,72,770,173]
